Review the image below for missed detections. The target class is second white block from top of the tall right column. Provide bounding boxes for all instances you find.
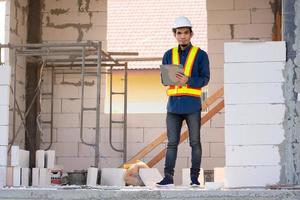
[224,62,285,84]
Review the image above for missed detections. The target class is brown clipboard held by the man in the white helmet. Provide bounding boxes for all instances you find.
[160,64,183,85]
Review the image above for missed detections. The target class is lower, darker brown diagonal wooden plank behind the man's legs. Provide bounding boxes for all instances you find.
[147,100,224,167]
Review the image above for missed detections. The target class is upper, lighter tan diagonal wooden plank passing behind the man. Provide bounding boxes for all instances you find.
[125,87,224,164]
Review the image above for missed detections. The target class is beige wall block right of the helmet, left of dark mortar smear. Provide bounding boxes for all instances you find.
[207,24,233,39]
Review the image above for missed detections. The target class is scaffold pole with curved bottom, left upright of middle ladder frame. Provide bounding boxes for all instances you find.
[80,47,95,146]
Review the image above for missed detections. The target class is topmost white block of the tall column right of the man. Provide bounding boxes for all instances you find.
[224,41,286,63]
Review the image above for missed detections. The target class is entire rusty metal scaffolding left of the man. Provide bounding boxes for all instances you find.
[0,41,131,167]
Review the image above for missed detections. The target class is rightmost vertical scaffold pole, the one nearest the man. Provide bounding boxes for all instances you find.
[123,62,128,163]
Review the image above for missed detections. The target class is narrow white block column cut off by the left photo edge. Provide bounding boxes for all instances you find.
[0,66,11,188]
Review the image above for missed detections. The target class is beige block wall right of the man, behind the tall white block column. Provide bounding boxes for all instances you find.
[206,0,274,175]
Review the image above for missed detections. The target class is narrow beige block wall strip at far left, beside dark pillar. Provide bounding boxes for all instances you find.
[6,0,28,147]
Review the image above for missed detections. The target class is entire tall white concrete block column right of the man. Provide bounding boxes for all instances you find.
[224,41,286,187]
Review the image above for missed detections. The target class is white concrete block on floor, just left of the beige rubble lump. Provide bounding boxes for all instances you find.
[101,168,126,186]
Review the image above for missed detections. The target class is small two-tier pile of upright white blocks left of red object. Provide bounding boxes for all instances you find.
[32,150,55,186]
